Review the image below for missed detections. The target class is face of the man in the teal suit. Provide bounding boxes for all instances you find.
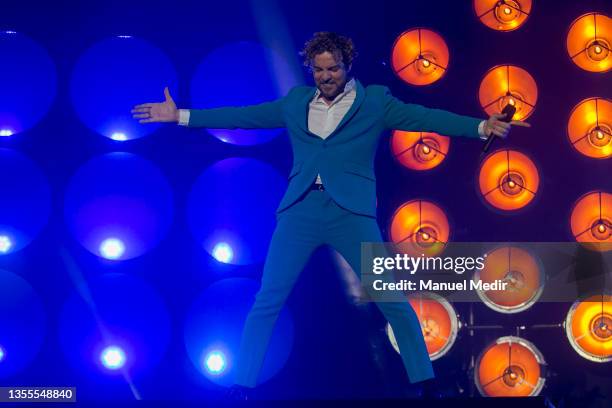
[311,51,350,101]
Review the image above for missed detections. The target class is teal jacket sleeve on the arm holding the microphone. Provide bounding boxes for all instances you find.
[383,87,482,138]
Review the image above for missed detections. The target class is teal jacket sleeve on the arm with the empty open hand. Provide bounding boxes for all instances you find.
[188,98,285,129]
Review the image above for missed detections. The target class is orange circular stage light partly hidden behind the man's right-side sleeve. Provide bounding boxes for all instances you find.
[390,130,450,170]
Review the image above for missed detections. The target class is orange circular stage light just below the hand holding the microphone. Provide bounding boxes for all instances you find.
[478,150,540,211]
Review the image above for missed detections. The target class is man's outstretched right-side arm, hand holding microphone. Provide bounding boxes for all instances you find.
[383,87,530,138]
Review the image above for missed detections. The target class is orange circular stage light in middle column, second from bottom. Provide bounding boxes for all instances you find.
[473,246,544,313]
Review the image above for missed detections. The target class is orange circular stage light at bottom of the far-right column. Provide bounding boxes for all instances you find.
[565,294,612,363]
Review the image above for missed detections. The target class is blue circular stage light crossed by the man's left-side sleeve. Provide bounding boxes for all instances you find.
[191,41,295,145]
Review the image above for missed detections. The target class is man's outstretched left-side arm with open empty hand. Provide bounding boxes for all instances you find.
[132,87,285,129]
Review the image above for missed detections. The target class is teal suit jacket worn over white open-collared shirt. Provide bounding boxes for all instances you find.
[189,81,482,217]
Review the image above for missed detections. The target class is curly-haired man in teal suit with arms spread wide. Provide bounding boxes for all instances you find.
[132,32,528,396]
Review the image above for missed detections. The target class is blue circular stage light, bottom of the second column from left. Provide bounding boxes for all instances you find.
[58,273,170,375]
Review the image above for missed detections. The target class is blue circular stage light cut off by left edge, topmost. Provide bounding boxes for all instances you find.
[0,31,57,137]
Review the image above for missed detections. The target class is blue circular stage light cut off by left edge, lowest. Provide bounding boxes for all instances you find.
[0,269,46,379]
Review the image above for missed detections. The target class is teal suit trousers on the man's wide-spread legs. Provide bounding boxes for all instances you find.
[234,190,434,387]
